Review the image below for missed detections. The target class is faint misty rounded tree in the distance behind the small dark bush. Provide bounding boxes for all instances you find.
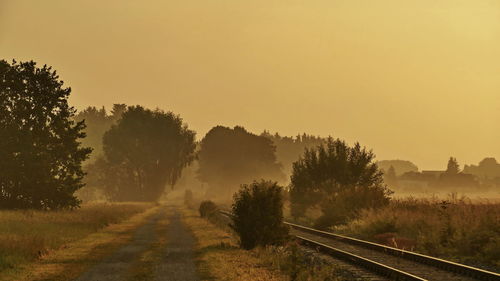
[198,126,284,198]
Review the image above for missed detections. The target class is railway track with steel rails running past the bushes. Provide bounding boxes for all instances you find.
[220,211,500,281]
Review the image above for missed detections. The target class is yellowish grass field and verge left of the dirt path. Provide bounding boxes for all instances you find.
[0,203,154,281]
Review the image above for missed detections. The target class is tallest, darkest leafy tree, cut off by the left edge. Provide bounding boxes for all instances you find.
[0,60,91,209]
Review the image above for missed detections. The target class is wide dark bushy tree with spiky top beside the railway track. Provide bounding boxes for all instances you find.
[290,138,390,228]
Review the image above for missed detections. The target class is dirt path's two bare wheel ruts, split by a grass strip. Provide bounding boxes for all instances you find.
[75,207,199,281]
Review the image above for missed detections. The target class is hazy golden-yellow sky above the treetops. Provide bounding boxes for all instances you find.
[0,0,500,169]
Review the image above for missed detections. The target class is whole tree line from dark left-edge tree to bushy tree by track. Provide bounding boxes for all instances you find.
[0,61,390,227]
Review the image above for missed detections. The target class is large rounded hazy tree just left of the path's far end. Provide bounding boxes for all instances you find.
[101,106,196,201]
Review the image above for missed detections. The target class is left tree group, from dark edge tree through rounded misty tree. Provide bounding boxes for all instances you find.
[0,61,196,209]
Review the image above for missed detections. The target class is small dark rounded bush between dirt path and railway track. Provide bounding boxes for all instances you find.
[232,180,288,247]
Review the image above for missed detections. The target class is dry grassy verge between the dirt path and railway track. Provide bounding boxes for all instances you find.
[184,206,358,281]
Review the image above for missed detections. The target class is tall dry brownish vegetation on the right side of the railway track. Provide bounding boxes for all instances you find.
[334,196,500,271]
